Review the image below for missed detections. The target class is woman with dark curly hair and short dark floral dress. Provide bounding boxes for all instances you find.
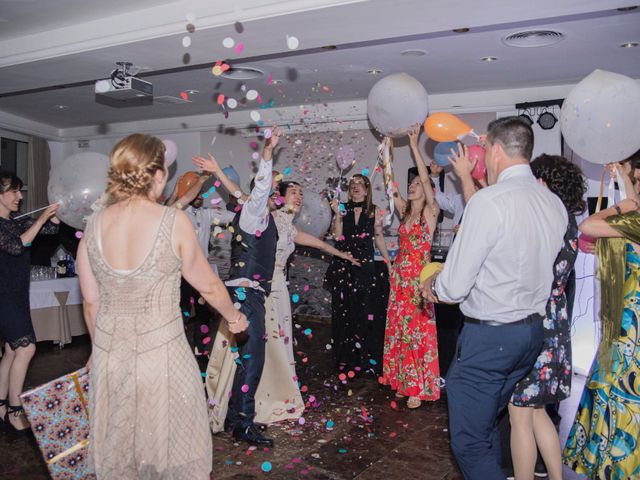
[509,154,587,480]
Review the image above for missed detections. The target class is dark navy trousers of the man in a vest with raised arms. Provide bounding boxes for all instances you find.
[227,287,265,428]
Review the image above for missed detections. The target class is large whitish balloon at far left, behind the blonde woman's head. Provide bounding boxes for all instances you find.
[47,152,109,230]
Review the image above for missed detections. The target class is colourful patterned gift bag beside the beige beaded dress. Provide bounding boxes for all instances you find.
[20,368,95,480]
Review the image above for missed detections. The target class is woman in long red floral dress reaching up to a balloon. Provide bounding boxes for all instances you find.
[380,126,440,408]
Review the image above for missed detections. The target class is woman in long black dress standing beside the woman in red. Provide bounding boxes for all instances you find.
[325,174,391,372]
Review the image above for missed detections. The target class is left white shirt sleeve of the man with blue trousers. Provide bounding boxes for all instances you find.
[435,194,502,303]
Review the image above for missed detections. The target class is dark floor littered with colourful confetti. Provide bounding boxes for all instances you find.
[0,318,582,480]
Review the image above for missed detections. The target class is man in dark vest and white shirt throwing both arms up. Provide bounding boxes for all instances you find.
[193,128,284,447]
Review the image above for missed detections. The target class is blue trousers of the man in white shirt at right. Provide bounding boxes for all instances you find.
[447,315,543,480]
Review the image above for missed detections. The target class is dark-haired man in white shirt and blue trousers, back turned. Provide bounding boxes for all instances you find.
[423,117,568,480]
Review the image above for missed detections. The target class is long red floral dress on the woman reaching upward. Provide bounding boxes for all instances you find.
[380,222,440,400]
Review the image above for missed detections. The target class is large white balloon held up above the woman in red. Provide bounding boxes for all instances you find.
[367,73,429,137]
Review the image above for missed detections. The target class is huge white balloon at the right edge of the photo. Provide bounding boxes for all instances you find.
[560,70,640,164]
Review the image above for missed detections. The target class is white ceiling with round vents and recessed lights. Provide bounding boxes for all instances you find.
[0,0,640,135]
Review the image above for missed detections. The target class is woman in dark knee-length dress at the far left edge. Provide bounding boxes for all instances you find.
[0,171,60,433]
